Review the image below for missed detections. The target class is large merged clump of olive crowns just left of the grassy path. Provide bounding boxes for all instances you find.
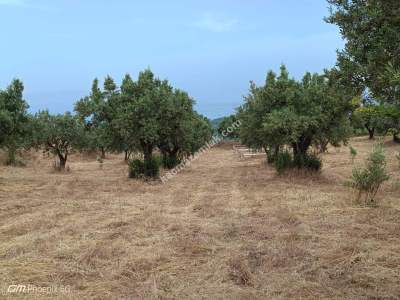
[75,69,212,176]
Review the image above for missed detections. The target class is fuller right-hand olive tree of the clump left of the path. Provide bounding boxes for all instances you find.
[118,70,212,167]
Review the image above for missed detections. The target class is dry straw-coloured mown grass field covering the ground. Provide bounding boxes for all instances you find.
[0,137,400,299]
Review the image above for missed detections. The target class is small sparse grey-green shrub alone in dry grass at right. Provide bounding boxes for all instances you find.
[350,146,389,204]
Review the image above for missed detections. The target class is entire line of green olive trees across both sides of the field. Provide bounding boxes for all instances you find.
[0,0,400,184]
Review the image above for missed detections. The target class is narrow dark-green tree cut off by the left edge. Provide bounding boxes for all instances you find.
[0,79,30,165]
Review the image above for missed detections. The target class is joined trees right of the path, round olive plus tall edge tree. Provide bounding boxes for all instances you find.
[219,0,400,176]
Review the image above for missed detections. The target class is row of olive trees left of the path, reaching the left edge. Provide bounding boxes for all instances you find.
[0,70,212,176]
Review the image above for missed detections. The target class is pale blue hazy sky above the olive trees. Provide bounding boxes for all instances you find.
[0,0,343,118]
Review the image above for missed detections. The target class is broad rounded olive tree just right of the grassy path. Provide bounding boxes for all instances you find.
[238,66,354,171]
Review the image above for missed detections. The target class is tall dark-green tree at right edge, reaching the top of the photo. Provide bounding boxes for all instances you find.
[326,0,400,142]
